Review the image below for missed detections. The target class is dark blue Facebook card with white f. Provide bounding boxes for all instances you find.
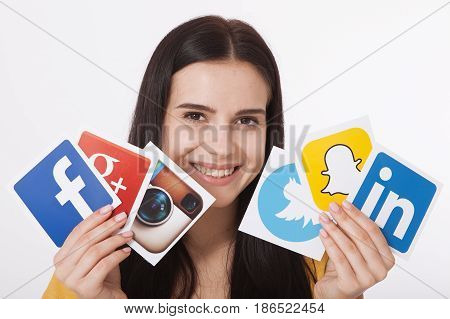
[14,140,120,247]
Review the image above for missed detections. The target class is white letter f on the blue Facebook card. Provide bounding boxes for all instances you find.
[53,156,92,214]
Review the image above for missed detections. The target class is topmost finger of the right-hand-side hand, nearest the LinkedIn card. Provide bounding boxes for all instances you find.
[342,201,395,269]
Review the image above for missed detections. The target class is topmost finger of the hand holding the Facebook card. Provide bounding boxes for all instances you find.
[54,205,113,264]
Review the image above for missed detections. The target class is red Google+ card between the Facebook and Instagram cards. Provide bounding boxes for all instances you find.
[78,131,156,229]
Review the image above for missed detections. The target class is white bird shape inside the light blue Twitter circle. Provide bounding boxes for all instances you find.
[275,178,319,227]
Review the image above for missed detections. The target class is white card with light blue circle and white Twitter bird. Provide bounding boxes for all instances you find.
[239,147,325,260]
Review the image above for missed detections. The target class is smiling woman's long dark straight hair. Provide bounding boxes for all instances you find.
[120,16,315,298]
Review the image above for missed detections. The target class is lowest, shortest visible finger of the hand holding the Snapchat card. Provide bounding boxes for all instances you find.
[319,229,355,282]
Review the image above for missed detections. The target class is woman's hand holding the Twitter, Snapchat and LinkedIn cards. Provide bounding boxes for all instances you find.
[314,201,395,298]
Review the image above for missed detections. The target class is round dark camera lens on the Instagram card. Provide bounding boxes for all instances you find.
[137,186,173,226]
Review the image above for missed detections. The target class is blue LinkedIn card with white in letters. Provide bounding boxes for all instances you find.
[348,144,441,258]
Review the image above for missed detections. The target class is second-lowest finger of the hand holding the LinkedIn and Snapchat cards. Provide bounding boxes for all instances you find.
[319,214,375,286]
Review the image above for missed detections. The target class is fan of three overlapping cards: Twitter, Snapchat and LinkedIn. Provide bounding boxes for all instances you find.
[239,118,440,260]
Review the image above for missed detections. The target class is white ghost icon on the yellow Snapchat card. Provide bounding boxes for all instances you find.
[321,144,361,195]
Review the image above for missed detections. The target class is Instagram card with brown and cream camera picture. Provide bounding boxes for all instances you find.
[124,143,215,265]
